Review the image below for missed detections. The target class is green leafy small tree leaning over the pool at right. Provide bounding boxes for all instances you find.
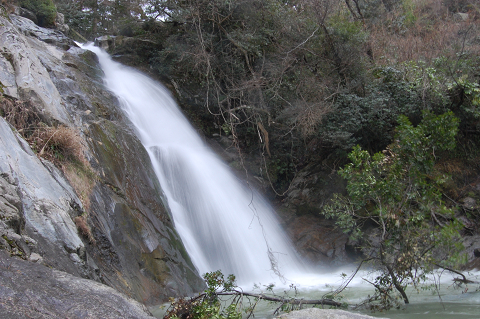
[324,112,463,307]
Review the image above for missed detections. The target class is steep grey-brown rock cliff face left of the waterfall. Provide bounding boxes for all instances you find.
[0,11,203,304]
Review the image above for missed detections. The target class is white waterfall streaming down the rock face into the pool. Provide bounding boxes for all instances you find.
[84,45,303,284]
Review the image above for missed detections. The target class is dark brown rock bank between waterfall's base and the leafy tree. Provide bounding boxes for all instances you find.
[282,164,357,267]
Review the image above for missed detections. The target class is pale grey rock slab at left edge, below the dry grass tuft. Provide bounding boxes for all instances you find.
[0,118,88,276]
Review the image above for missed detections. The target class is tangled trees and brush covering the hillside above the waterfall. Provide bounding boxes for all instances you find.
[40,0,480,194]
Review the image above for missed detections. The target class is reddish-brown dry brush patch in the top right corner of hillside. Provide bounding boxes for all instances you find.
[370,0,480,64]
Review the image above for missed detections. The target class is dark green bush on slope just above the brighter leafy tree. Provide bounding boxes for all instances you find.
[317,67,425,151]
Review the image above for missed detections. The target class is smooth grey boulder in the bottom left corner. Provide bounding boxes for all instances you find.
[0,252,154,319]
